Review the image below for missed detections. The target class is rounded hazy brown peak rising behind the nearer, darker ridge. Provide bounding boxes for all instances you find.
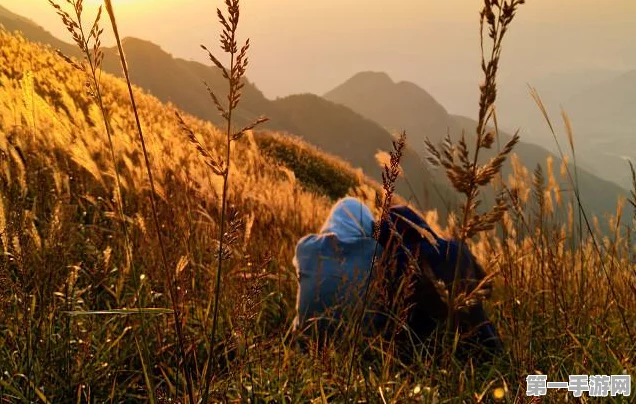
[325,72,628,223]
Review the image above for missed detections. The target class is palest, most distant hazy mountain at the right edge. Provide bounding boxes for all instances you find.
[498,69,636,188]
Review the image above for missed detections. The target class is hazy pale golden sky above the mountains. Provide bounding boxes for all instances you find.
[0,0,636,114]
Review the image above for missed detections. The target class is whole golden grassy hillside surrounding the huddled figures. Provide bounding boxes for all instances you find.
[0,19,636,402]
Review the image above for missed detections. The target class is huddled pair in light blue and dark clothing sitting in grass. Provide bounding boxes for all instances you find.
[294,197,503,358]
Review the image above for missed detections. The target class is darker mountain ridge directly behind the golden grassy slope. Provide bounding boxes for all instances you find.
[0,6,456,218]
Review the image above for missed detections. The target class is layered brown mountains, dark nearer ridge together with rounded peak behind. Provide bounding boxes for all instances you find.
[0,3,626,224]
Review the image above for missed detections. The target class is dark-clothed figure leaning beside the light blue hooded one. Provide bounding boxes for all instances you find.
[380,207,499,362]
